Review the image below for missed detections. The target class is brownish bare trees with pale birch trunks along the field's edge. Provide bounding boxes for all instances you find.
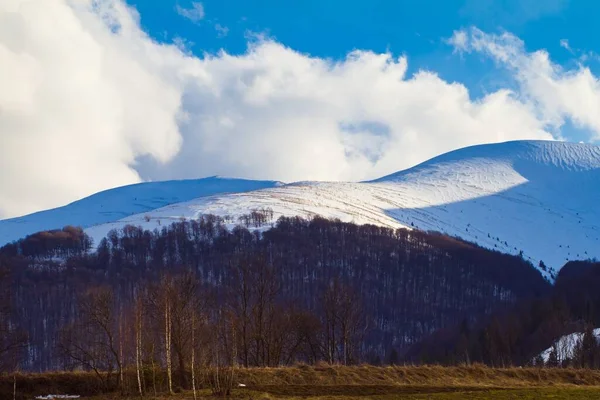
[57,268,366,394]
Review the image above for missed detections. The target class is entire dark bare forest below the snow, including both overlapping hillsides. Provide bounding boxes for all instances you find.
[0,210,600,387]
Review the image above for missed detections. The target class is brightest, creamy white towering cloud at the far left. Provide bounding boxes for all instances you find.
[0,0,188,217]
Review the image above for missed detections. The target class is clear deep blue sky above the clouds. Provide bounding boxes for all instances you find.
[128,0,600,96]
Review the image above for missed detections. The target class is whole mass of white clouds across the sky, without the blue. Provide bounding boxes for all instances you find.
[0,0,600,217]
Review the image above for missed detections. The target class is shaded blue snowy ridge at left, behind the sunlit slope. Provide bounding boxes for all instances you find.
[0,177,281,246]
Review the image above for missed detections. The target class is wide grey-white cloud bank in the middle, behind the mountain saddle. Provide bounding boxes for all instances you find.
[138,40,551,181]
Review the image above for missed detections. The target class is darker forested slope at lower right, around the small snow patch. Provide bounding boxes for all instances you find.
[406,261,600,368]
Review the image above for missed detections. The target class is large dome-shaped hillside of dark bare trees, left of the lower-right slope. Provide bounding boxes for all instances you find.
[0,214,550,370]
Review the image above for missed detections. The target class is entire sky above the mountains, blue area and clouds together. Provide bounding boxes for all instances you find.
[0,0,600,218]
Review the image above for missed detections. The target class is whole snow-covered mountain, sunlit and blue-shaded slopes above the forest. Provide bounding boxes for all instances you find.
[0,141,600,276]
